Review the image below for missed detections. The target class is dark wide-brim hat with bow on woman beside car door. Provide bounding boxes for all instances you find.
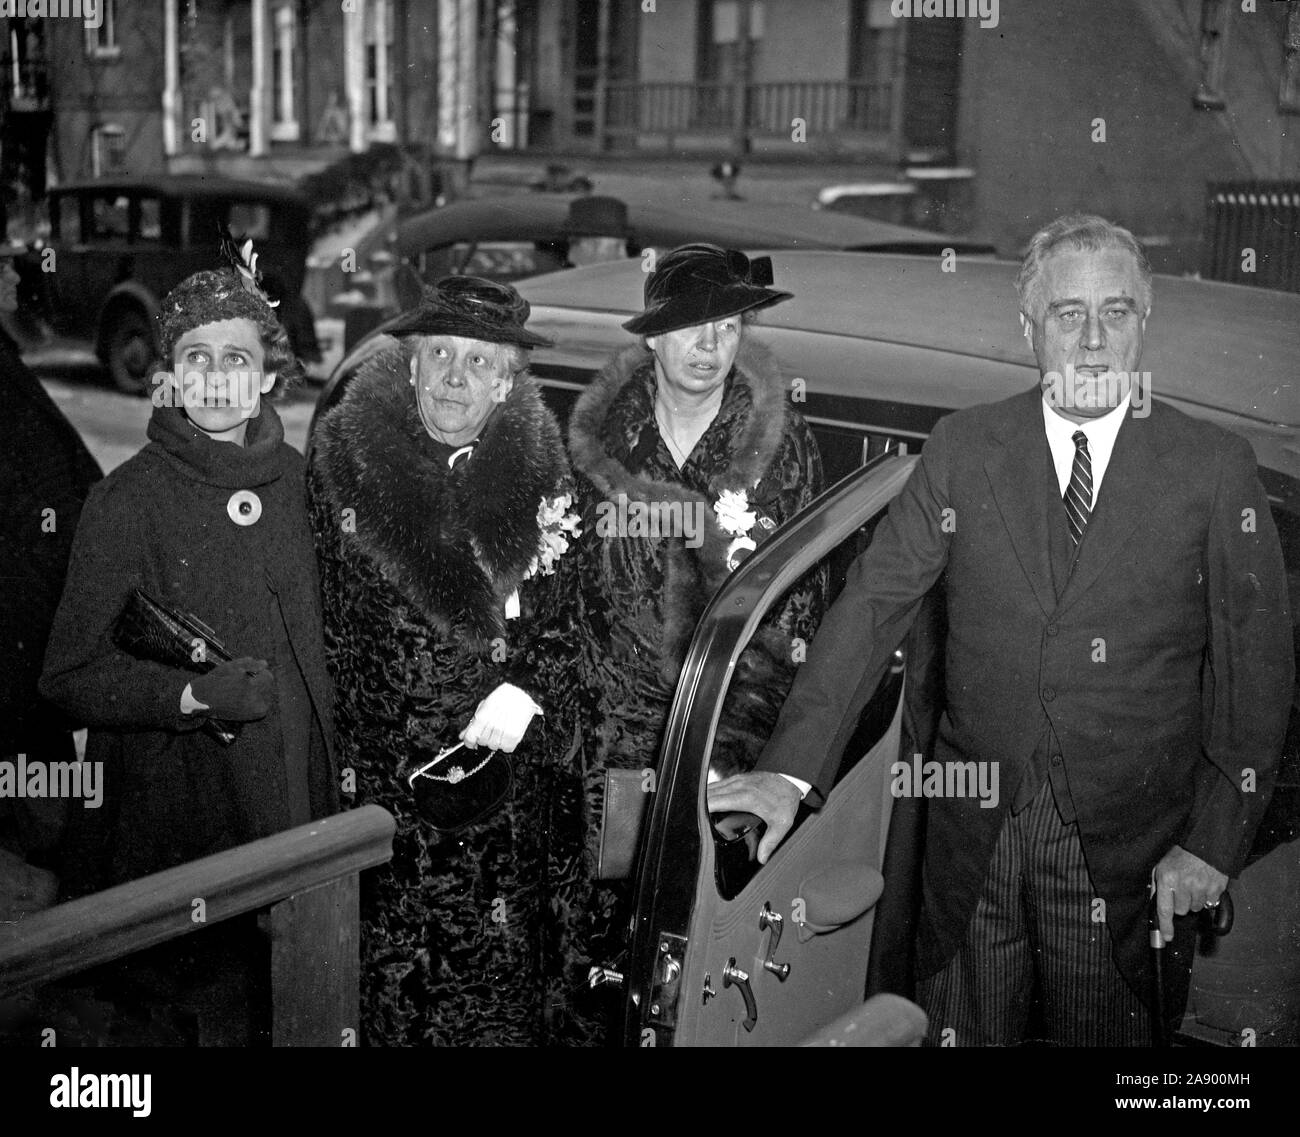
[623,244,794,335]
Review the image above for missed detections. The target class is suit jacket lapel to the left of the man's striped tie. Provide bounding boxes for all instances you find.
[982,387,1057,616]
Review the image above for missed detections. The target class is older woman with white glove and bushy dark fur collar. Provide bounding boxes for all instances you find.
[309,277,584,1046]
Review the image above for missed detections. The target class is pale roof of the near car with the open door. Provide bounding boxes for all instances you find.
[515,249,1300,428]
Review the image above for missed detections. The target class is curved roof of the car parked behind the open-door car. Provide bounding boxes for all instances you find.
[393,194,992,256]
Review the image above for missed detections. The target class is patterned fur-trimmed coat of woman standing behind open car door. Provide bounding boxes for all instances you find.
[562,335,826,1033]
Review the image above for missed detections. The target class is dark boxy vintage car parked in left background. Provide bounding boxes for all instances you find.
[46,175,316,392]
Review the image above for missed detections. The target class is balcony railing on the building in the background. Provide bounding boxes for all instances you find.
[605,79,894,148]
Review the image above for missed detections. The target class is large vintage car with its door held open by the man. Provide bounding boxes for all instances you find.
[309,251,1300,1045]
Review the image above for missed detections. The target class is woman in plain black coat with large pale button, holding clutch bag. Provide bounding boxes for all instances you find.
[42,270,338,1041]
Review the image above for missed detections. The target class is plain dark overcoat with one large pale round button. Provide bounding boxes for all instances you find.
[40,403,338,897]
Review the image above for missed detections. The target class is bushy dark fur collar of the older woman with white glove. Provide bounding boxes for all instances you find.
[313,348,568,639]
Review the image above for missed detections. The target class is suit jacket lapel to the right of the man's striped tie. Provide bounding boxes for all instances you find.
[1057,413,1169,613]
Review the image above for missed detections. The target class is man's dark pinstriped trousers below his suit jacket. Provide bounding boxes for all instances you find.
[917,781,1152,1046]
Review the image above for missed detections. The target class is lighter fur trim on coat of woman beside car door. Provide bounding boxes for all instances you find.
[569,337,789,682]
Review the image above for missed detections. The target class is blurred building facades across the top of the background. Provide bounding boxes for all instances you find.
[0,0,1300,280]
